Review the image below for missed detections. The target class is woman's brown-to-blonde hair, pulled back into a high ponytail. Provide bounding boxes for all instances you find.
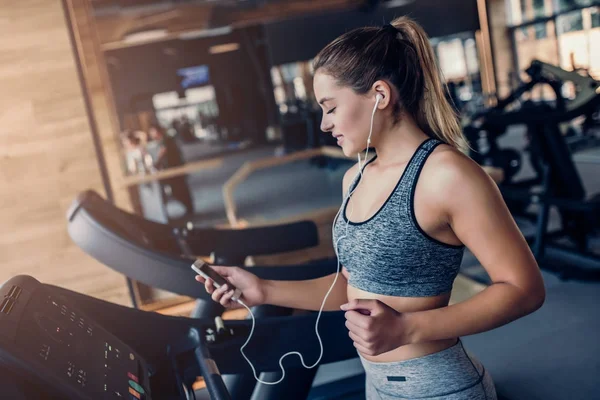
[313,17,469,152]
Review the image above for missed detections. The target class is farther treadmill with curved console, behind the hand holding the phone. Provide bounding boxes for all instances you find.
[67,191,364,400]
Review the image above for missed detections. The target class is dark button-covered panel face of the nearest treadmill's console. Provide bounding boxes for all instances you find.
[15,295,150,400]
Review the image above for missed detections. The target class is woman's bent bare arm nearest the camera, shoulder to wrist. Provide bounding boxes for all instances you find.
[403,151,545,343]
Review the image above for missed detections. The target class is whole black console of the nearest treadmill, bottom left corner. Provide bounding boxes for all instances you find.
[0,276,151,400]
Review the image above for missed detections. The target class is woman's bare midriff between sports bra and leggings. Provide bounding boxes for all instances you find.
[347,285,457,362]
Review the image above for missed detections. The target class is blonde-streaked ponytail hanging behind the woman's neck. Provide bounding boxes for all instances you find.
[391,17,469,153]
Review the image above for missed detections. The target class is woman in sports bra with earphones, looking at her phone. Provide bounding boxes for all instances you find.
[197,18,545,400]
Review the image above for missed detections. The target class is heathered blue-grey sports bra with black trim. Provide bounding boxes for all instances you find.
[333,139,464,297]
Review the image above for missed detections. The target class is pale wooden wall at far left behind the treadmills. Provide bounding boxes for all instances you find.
[0,0,129,304]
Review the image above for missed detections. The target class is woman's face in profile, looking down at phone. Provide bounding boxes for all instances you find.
[313,70,375,156]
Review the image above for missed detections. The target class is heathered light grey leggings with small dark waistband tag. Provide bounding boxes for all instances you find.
[359,339,496,400]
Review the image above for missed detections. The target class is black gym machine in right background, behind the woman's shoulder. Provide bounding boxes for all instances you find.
[464,60,600,280]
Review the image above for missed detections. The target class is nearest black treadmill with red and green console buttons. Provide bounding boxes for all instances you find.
[0,275,364,400]
